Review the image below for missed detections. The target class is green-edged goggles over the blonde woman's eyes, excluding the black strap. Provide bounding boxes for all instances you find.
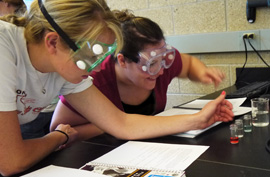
[71,41,117,72]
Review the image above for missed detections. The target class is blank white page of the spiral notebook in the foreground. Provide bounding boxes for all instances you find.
[88,141,209,171]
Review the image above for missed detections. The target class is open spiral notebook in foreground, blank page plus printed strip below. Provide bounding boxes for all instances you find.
[81,141,209,177]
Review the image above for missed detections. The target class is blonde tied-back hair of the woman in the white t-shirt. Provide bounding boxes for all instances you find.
[0,0,123,52]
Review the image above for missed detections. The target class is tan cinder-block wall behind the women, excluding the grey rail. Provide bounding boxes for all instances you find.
[107,0,270,108]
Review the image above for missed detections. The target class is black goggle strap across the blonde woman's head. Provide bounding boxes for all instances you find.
[38,0,79,52]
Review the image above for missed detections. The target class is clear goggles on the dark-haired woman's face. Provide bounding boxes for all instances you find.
[138,44,175,75]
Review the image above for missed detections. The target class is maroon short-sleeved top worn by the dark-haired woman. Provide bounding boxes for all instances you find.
[60,50,182,115]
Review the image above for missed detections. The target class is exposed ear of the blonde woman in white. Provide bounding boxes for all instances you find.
[44,32,60,54]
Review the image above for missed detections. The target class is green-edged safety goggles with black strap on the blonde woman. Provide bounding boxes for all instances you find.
[38,0,117,72]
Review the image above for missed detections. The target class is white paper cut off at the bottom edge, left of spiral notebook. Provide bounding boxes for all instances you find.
[22,165,108,177]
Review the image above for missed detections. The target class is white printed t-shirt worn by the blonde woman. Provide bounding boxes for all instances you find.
[0,20,92,124]
